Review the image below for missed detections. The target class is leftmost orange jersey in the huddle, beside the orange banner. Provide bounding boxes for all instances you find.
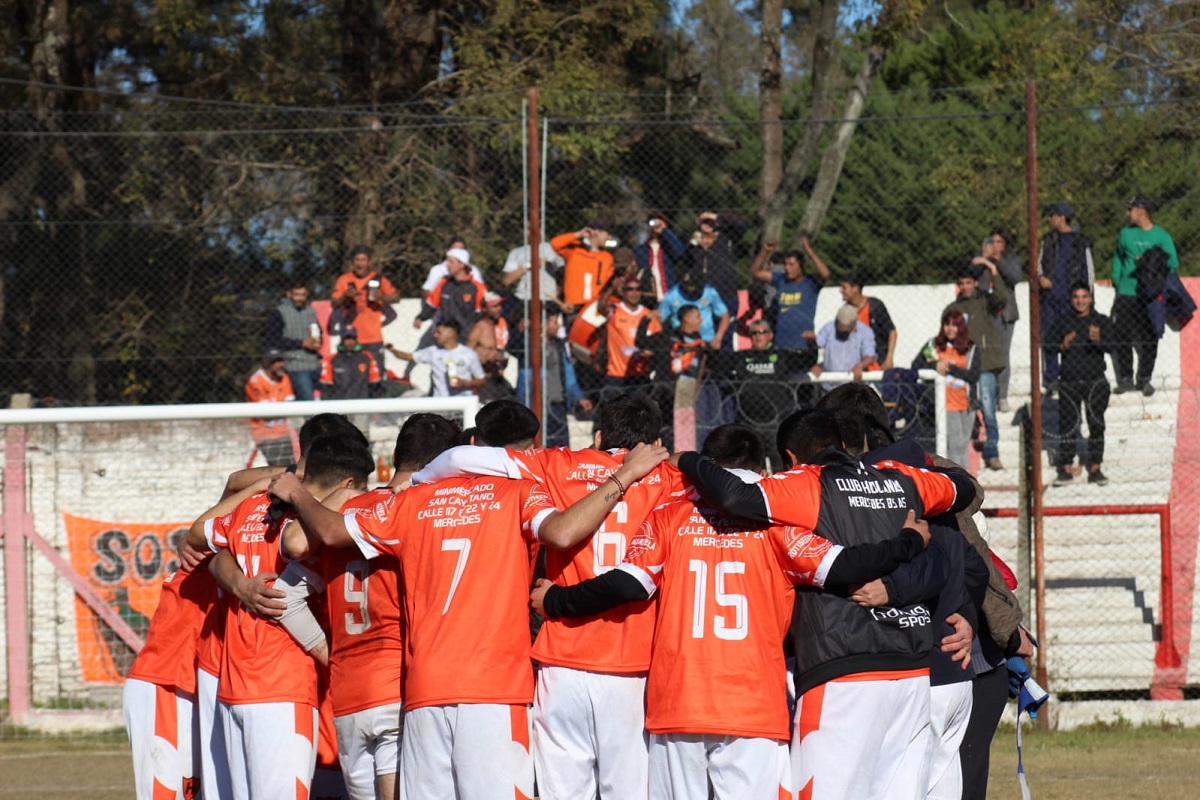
[127,566,217,694]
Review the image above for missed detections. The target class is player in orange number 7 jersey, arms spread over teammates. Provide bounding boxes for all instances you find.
[270,407,666,800]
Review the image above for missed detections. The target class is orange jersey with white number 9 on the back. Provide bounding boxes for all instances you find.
[320,488,404,716]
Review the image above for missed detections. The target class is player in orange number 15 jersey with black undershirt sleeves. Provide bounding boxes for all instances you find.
[532,426,928,800]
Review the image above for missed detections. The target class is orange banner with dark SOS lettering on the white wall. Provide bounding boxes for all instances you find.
[62,513,191,684]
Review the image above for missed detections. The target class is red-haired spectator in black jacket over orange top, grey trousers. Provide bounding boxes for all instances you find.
[912,309,979,465]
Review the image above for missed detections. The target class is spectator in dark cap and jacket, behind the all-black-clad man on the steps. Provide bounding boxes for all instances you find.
[1038,203,1096,393]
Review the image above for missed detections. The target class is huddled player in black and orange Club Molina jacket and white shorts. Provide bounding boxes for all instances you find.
[679,409,974,800]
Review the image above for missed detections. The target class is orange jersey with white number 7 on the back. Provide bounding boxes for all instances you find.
[346,477,556,709]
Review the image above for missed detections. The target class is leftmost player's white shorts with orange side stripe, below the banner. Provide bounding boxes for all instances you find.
[121,678,199,800]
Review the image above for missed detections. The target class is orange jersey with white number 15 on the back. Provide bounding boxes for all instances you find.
[620,500,842,741]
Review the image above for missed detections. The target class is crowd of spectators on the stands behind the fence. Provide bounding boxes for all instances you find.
[247,197,1190,483]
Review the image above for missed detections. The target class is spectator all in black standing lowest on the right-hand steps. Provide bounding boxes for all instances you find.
[1048,283,1114,486]
